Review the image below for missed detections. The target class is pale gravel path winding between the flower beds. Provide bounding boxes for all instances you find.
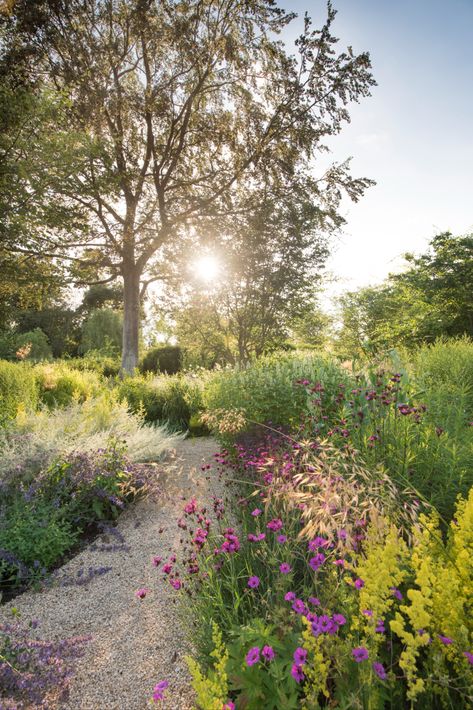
[0,439,222,710]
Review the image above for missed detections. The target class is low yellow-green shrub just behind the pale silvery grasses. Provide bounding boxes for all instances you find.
[35,363,103,409]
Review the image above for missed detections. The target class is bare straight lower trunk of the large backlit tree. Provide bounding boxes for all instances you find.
[122,265,140,375]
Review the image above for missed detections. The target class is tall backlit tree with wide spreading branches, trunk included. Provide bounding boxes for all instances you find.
[1,0,374,371]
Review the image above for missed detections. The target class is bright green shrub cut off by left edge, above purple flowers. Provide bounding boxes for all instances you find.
[0,360,38,426]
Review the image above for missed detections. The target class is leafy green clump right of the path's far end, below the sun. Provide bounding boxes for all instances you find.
[204,353,349,434]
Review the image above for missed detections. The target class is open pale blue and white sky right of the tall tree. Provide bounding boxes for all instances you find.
[279,0,473,298]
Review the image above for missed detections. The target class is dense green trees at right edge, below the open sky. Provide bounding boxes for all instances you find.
[336,232,473,357]
